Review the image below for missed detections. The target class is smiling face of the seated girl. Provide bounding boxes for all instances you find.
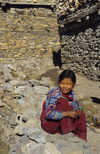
[59,78,74,94]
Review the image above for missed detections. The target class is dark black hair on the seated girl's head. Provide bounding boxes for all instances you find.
[58,70,76,84]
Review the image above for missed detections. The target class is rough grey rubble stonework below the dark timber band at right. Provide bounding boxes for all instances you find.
[61,24,100,81]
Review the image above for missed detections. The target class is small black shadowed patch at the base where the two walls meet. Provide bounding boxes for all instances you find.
[53,50,62,68]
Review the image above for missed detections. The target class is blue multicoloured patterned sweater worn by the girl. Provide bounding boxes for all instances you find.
[44,87,81,120]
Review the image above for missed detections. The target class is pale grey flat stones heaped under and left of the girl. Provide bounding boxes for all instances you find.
[0,60,97,154]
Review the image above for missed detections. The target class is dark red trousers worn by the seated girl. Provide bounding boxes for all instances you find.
[40,98,87,141]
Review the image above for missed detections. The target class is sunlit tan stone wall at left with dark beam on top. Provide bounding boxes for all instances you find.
[0,1,60,59]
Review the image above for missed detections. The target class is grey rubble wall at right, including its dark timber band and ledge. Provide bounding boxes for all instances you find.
[59,3,100,81]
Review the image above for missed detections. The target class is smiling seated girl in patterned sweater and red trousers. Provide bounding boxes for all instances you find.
[40,70,87,141]
